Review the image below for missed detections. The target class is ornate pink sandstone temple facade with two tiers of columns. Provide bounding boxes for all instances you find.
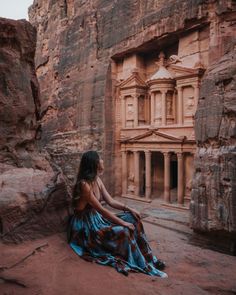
[113,43,204,206]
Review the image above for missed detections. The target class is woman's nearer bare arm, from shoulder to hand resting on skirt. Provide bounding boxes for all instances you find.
[81,182,134,230]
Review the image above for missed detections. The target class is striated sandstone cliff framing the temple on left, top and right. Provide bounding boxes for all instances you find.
[30,0,236,239]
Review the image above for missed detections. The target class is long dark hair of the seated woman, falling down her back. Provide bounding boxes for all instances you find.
[72,151,100,204]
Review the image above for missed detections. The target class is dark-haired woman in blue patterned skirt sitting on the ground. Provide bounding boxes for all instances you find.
[68,151,167,277]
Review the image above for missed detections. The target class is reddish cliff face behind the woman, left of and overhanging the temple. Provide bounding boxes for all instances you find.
[30,0,207,190]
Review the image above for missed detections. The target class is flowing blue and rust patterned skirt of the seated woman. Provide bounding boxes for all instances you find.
[68,208,167,277]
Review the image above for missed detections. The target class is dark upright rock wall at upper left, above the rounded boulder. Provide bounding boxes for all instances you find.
[0,18,40,167]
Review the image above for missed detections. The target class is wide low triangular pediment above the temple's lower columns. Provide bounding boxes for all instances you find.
[122,130,184,143]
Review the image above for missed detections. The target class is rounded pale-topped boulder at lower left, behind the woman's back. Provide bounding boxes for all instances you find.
[0,168,69,242]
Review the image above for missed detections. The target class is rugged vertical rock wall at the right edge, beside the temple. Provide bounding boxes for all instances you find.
[191,5,236,239]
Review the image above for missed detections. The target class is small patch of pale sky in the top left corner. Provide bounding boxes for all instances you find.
[0,0,34,20]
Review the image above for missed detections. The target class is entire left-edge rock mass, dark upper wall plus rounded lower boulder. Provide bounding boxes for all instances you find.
[0,18,68,242]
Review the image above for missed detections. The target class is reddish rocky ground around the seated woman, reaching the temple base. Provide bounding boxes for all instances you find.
[0,201,236,295]
